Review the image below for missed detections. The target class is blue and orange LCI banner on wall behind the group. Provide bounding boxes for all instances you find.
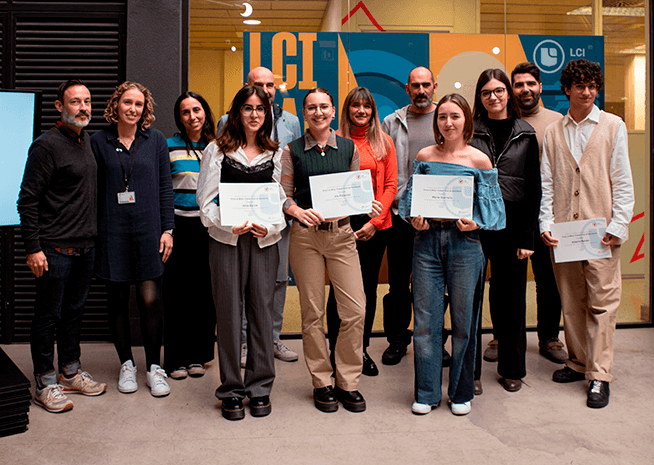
[243,32,604,128]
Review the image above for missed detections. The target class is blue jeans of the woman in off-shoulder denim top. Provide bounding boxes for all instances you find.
[412,221,484,405]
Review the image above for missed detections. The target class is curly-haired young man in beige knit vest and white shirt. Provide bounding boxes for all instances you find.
[539,59,634,408]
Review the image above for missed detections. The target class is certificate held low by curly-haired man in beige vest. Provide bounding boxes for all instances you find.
[550,218,611,263]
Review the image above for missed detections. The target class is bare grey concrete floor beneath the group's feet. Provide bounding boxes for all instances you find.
[0,328,654,465]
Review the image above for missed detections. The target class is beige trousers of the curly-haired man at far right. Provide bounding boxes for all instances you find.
[553,246,622,382]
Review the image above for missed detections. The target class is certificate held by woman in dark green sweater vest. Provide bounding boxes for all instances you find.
[309,170,375,218]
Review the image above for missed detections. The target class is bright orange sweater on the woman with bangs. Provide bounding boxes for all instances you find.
[350,125,397,230]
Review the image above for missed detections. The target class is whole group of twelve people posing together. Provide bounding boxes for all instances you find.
[18,59,633,420]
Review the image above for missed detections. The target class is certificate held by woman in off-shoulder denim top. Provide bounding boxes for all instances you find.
[410,174,475,220]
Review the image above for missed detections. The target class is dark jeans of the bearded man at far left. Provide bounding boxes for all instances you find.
[30,247,95,389]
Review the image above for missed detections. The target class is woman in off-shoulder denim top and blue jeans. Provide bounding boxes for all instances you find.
[399,94,505,415]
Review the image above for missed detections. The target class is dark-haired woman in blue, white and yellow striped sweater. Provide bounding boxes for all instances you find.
[164,92,216,379]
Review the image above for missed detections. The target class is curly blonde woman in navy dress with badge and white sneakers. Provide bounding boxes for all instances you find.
[91,81,174,397]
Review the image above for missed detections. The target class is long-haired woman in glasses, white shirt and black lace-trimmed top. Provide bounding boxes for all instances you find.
[197,85,285,420]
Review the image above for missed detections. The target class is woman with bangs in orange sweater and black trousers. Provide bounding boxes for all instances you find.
[327,87,397,376]
